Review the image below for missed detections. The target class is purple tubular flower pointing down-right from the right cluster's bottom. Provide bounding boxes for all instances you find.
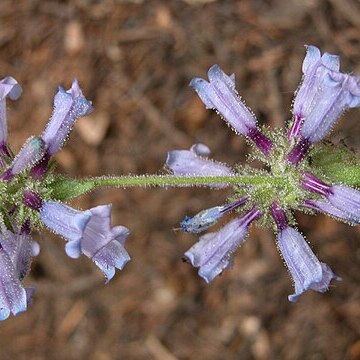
[271,203,340,302]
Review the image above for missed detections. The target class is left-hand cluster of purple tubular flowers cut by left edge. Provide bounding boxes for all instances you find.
[0,77,130,320]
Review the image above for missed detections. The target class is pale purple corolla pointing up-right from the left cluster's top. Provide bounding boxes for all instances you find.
[42,80,93,156]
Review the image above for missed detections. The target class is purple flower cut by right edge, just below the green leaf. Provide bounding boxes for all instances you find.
[302,173,360,223]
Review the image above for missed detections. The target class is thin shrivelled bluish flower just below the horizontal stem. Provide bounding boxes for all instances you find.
[180,196,249,233]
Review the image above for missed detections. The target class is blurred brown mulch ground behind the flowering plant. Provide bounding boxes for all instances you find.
[0,0,360,360]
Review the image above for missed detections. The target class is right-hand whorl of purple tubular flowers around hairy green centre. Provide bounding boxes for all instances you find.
[166,46,360,301]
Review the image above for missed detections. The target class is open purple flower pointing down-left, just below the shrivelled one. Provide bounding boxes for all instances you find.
[185,207,261,283]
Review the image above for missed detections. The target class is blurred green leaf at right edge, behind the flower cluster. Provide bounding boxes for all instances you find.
[311,144,360,186]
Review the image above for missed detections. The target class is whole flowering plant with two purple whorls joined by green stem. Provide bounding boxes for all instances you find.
[0,46,360,320]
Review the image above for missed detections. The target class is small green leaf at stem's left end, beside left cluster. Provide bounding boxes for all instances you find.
[49,176,96,201]
